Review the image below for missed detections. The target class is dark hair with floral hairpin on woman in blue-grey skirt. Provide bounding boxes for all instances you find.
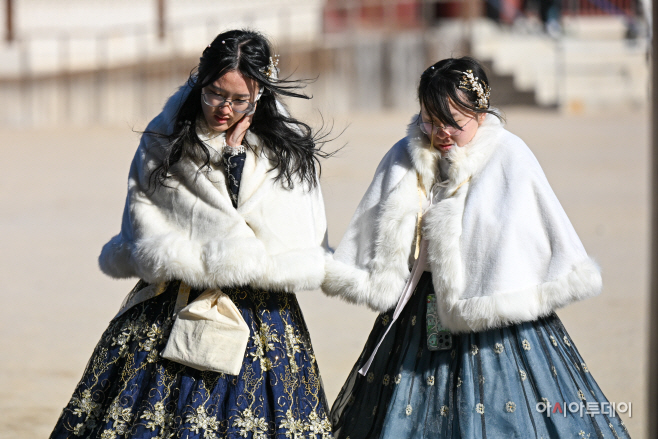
[418,56,501,129]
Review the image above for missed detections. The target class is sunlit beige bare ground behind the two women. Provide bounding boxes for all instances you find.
[0,105,649,439]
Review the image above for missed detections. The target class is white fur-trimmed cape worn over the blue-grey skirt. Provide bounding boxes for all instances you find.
[322,115,601,333]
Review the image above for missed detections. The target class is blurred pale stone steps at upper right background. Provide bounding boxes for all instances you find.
[472,19,649,110]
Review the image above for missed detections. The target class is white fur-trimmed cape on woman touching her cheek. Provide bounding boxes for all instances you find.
[99,86,327,292]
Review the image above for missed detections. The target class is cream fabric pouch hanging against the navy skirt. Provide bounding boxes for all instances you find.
[160,289,249,375]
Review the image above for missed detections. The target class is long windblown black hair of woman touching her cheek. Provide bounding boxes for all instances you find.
[150,30,331,188]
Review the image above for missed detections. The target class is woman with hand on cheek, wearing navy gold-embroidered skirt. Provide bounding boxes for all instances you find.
[51,30,331,438]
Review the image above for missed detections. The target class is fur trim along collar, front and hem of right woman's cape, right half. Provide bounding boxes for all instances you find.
[423,115,602,333]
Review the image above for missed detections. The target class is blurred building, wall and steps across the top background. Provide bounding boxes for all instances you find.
[0,0,650,126]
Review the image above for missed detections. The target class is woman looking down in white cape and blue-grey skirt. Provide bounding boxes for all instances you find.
[323,57,628,439]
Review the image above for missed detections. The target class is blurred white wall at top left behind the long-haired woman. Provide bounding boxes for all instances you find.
[0,0,324,78]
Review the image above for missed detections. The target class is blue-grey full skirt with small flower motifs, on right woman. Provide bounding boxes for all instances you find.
[331,273,629,439]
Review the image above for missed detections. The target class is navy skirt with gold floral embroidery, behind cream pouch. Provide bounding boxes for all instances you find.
[50,281,331,439]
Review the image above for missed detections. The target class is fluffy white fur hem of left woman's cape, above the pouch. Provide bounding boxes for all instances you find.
[99,233,326,292]
